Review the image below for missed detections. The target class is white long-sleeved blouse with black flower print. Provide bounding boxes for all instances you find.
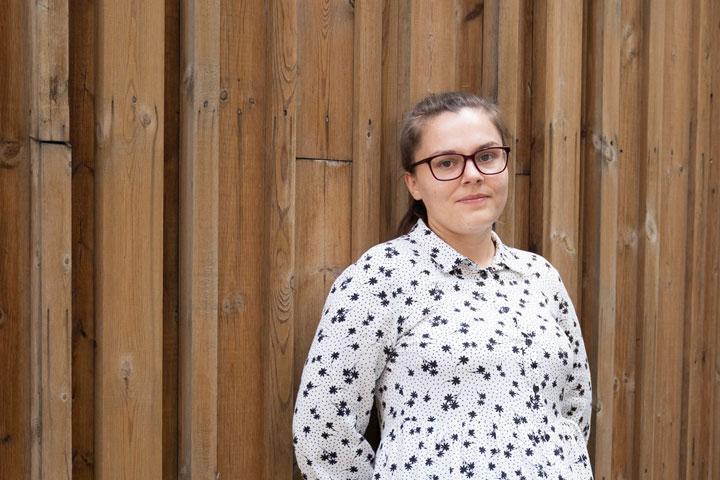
[293,221,592,480]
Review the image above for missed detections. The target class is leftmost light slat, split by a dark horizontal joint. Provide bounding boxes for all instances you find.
[30,0,72,480]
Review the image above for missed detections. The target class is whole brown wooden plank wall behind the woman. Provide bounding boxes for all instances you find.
[0,0,720,480]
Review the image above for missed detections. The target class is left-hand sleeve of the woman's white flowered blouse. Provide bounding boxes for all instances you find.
[293,255,396,480]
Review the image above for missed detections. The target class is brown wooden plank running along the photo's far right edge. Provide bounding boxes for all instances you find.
[680,1,718,478]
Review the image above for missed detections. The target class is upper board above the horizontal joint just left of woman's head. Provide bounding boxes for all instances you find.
[297,0,356,160]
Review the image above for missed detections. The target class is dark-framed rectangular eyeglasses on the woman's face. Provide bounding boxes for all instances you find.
[410,146,510,182]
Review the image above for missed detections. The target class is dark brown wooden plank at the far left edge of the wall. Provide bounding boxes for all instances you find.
[0,7,31,480]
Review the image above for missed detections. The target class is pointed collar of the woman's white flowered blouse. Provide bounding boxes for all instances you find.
[408,219,526,276]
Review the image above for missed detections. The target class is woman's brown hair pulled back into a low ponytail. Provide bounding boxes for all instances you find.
[398,92,510,235]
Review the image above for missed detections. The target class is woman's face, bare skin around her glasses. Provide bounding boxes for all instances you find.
[405,108,508,236]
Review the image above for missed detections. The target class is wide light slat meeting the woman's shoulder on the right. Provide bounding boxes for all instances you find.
[536,0,583,311]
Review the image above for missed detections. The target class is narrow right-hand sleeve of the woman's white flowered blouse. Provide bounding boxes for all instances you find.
[554,274,592,443]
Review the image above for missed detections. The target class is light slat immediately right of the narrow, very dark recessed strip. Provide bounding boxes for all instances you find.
[179,0,220,479]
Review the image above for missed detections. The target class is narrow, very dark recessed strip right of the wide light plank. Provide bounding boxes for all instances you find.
[162,0,182,480]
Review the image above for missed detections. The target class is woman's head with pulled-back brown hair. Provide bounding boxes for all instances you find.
[400,92,509,235]
